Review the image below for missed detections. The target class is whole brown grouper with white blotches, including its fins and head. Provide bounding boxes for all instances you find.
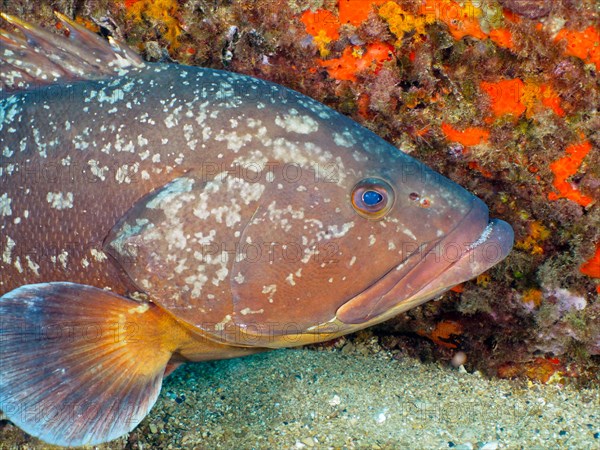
[0,14,513,445]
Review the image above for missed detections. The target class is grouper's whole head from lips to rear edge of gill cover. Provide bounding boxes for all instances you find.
[90,67,513,346]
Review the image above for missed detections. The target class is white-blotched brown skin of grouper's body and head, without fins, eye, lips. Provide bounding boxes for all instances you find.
[0,65,512,344]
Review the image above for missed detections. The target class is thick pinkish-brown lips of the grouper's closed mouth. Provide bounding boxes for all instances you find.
[336,198,514,326]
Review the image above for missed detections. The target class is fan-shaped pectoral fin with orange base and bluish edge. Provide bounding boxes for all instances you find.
[0,283,180,446]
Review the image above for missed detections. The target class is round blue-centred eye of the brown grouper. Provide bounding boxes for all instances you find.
[352,178,394,220]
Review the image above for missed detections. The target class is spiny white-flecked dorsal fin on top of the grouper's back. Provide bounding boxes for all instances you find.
[0,12,144,92]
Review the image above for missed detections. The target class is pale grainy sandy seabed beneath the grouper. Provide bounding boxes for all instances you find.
[0,349,600,450]
